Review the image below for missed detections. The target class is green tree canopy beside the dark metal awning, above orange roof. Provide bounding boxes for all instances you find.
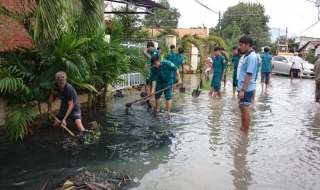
[143,0,181,28]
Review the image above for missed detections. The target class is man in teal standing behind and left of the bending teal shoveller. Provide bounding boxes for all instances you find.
[142,42,162,92]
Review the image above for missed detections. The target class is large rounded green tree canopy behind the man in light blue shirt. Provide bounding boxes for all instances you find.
[221,2,270,47]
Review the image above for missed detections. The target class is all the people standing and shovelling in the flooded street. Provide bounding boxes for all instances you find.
[48,35,320,137]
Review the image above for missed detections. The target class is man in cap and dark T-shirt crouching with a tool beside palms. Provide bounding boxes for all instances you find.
[48,71,85,132]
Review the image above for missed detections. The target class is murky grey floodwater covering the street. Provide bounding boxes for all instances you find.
[0,75,320,190]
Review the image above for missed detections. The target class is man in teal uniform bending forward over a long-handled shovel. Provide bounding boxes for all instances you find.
[150,55,181,114]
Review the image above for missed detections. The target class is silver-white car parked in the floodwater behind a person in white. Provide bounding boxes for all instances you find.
[272,56,314,78]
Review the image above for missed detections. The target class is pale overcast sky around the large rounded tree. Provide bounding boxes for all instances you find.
[169,0,320,37]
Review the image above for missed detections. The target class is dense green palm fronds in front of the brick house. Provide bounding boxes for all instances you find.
[0,0,144,139]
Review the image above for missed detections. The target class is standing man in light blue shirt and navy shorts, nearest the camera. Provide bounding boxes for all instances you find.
[238,36,257,135]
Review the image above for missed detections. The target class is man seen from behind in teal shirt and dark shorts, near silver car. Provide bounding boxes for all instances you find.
[260,47,272,90]
